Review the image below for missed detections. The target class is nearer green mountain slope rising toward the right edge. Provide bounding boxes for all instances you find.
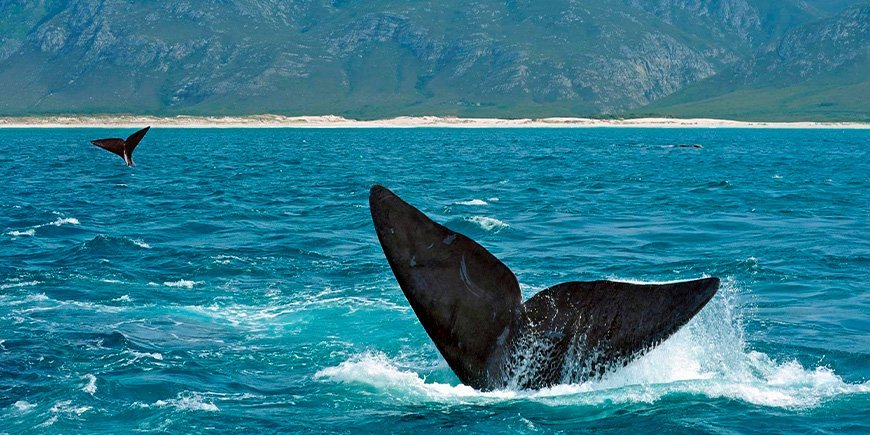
[638,5,870,122]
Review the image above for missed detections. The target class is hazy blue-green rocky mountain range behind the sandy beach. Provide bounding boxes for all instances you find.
[0,0,870,119]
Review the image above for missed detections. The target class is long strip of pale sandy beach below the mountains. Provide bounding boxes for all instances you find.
[0,115,870,129]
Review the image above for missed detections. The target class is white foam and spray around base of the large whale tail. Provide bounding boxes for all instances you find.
[314,282,870,409]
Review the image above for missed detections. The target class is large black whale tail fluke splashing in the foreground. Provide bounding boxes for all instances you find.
[369,185,720,391]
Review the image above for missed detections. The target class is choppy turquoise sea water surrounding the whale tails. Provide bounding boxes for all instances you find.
[0,129,870,433]
